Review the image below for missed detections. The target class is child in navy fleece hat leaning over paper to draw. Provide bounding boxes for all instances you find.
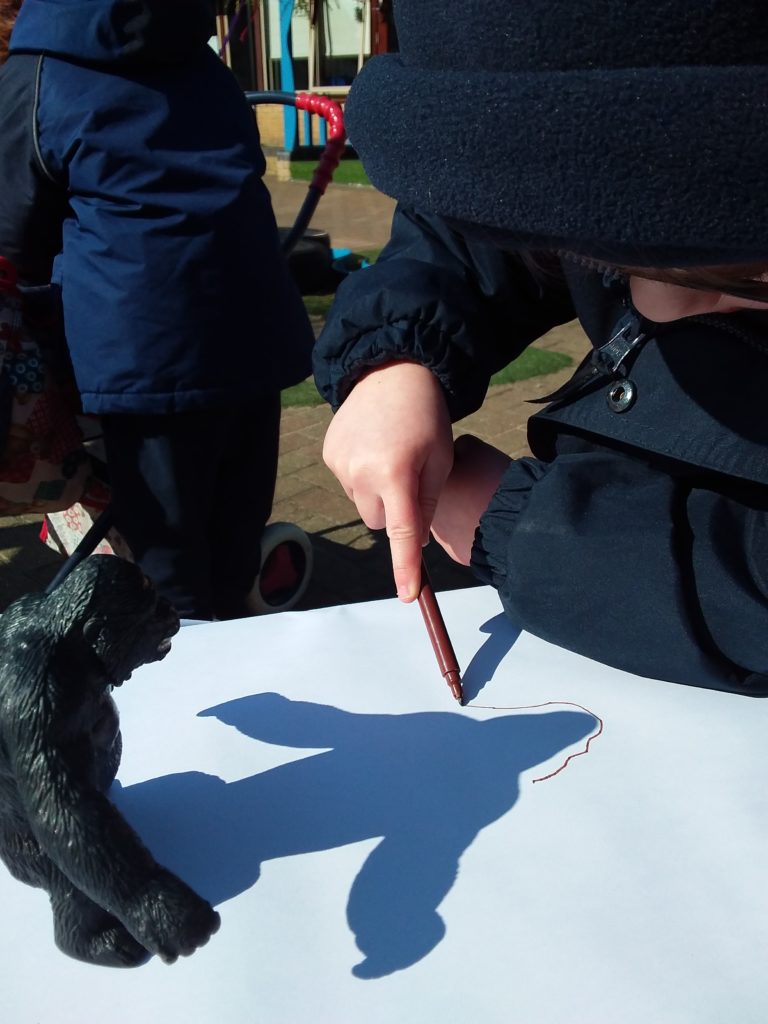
[315,0,768,693]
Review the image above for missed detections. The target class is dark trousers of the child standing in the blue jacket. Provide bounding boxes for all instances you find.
[101,394,280,618]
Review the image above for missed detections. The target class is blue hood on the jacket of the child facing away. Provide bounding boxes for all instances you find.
[9,0,216,63]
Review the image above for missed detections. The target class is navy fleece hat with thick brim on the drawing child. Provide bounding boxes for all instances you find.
[344,0,768,266]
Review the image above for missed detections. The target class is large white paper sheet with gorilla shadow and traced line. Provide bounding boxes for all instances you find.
[0,588,768,1024]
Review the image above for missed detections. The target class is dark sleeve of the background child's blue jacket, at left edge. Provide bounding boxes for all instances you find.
[0,54,68,285]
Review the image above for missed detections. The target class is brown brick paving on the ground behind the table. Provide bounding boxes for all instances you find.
[0,180,587,610]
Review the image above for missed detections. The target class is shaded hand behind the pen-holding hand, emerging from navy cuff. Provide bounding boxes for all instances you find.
[432,434,511,565]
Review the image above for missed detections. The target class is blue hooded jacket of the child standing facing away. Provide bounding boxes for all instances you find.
[0,0,312,414]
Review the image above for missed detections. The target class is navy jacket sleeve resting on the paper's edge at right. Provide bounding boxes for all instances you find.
[472,450,768,695]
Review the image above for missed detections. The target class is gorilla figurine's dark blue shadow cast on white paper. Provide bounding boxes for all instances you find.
[111,693,595,978]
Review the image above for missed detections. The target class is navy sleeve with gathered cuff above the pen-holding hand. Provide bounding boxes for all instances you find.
[314,207,575,420]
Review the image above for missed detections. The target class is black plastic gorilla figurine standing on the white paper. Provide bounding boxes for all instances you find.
[0,555,219,967]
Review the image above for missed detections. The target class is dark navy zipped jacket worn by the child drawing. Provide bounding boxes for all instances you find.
[314,207,768,695]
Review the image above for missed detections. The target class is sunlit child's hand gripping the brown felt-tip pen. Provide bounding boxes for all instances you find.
[323,362,454,601]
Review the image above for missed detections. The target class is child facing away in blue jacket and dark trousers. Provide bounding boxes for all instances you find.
[0,0,313,618]
